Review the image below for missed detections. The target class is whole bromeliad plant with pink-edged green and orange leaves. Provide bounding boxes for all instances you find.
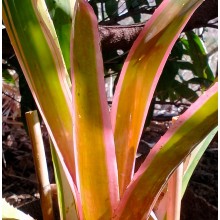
[3,0,217,220]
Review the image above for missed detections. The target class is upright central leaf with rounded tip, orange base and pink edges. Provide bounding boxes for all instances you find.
[71,0,119,220]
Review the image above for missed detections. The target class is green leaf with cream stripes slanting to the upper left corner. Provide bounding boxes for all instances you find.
[3,0,75,183]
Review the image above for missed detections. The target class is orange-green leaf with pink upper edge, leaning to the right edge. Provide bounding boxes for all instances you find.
[114,83,218,219]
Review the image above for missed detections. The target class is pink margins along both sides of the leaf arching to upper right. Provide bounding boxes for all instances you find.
[111,0,202,194]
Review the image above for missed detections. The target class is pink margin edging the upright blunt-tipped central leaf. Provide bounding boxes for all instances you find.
[70,0,119,209]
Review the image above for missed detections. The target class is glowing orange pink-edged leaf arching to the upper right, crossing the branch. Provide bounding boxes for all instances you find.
[111,0,202,195]
